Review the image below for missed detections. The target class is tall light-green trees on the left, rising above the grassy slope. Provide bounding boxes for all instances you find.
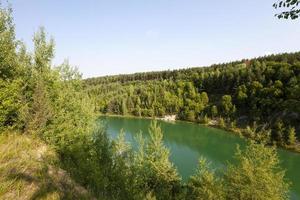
[0,5,97,198]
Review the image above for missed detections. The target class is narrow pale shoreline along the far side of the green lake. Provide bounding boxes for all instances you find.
[97,113,300,154]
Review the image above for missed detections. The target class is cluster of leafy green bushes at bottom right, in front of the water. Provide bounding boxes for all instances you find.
[187,142,289,200]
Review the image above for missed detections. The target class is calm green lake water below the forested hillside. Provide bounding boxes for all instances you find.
[101,117,300,199]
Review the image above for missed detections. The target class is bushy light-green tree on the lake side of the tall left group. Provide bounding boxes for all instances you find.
[44,63,97,149]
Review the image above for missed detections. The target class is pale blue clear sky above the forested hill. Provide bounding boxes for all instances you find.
[9,0,300,78]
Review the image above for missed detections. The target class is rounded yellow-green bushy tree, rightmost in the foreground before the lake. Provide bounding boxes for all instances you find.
[225,142,289,200]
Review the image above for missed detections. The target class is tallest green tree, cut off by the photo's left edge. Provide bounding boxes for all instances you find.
[0,7,24,131]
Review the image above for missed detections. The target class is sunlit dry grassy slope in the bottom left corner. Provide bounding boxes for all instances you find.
[0,133,94,200]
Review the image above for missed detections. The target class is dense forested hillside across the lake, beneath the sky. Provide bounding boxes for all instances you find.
[85,52,300,148]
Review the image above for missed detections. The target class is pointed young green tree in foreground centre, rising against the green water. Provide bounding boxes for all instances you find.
[134,121,180,199]
